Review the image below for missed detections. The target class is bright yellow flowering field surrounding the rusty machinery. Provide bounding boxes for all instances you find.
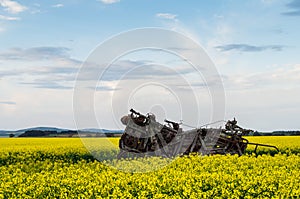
[0,136,300,198]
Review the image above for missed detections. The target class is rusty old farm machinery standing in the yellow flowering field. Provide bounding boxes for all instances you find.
[118,109,278,158]
